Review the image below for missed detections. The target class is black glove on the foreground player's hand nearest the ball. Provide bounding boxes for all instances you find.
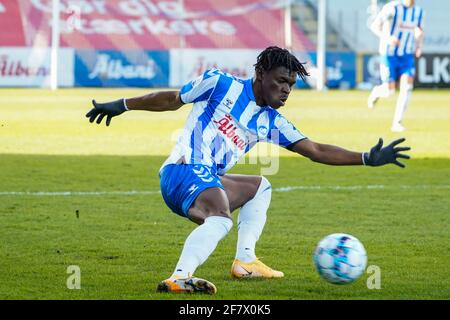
[363,138,411,168]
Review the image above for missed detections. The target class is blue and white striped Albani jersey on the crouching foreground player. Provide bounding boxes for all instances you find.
[161,69,305,175]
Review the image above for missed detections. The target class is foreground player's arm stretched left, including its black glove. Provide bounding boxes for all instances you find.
[86,91,184,126]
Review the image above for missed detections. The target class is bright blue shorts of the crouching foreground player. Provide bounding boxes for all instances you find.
[160,164,225,218]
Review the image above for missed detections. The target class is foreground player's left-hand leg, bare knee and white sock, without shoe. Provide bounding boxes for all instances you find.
[172,187,233,278]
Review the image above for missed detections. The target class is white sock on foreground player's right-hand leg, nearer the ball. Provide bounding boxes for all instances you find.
[236,177,272,263]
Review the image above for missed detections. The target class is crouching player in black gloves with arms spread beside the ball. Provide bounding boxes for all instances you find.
[86,47,410,294]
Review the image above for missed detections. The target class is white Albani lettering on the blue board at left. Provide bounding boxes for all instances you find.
[89,54,156,80]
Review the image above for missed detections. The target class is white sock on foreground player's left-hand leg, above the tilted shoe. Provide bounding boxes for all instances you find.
[172,216,233,278]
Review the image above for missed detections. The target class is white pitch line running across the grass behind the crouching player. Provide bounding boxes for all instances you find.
[0,185,450,197]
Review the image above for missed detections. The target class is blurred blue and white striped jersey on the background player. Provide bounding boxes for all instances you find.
[375,1,424,56]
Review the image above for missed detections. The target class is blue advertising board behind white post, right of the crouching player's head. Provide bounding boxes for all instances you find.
[297,52,356,89]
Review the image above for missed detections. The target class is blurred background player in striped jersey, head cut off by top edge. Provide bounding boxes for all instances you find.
[368,0,424,132]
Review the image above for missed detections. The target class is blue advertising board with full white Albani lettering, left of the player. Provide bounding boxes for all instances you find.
[75,50,169,87]
